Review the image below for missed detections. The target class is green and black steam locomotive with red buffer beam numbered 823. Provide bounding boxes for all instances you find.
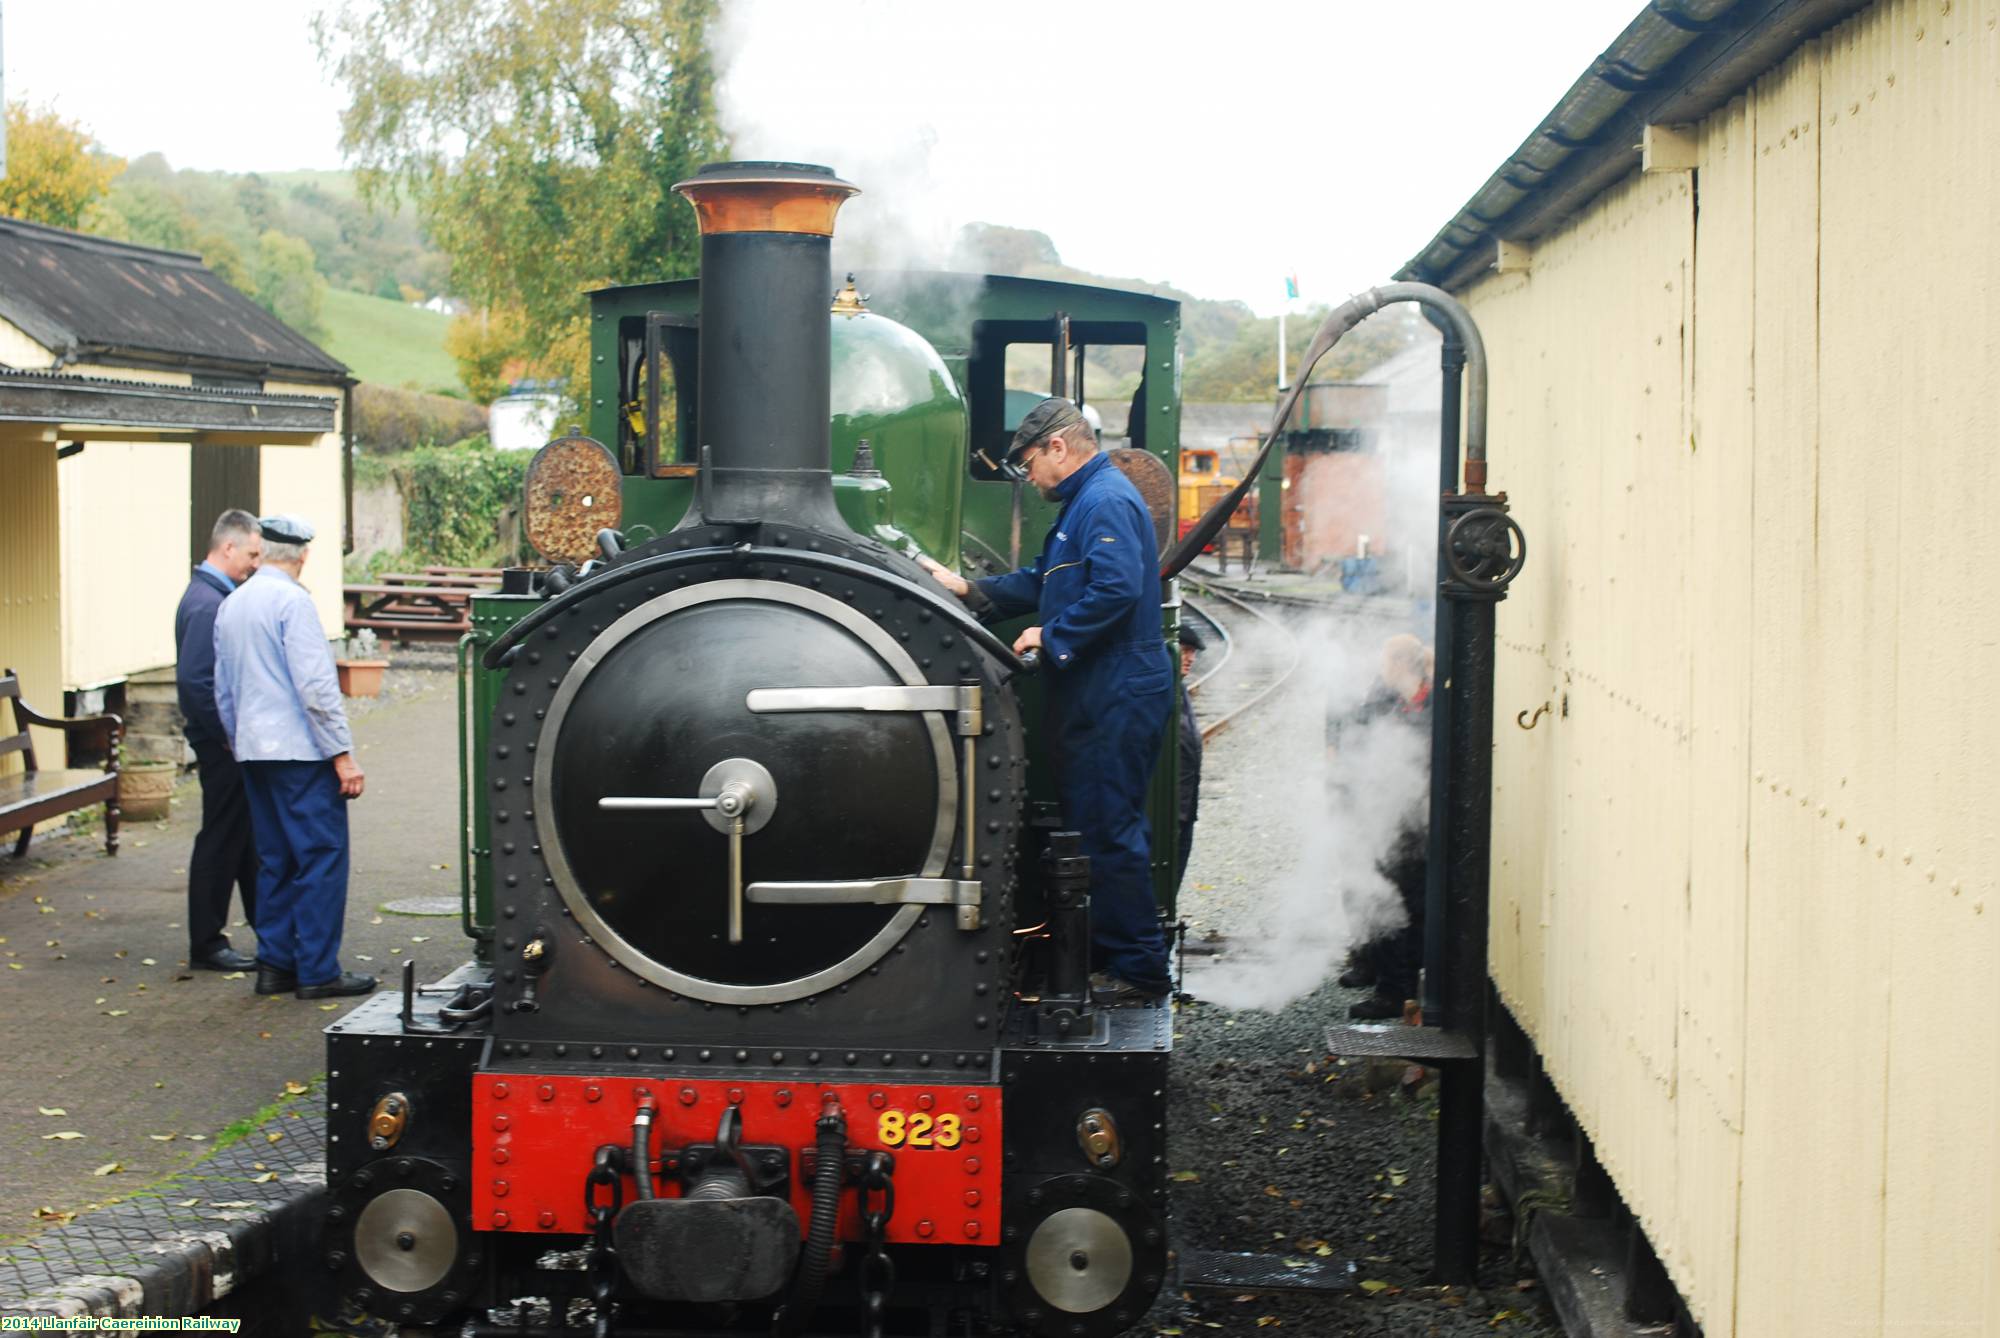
[320,162,1180,1338]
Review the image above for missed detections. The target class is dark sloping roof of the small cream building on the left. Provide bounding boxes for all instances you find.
[0,218,348,380]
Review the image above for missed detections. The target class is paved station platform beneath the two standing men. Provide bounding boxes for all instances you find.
[0,660,470,1316]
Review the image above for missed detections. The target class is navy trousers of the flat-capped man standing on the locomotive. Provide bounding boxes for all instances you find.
[1054,648,1174,990]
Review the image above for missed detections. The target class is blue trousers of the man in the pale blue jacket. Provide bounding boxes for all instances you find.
[242,762,348,986]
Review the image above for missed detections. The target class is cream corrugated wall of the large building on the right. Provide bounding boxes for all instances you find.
[1462,0,2000,1338]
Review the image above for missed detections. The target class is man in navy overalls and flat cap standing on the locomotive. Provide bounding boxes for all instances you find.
[928,398,1174,1004]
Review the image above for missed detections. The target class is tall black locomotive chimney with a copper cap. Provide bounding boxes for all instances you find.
[674,162,858,530]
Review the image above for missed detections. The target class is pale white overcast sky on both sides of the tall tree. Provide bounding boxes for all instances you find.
[0,0,1640,314]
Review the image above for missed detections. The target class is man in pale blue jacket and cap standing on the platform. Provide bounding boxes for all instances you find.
[216,516,376,998]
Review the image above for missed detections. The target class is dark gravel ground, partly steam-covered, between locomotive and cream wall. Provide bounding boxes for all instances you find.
[1140,608,1562,1338]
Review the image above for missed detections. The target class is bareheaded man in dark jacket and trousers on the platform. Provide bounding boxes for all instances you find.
[174,510,264,970]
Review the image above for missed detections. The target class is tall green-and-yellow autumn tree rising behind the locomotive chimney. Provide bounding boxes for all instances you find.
[316,0,726,396]
